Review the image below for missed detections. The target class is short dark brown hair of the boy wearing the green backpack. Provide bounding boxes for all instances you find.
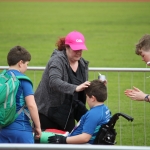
[7,46,31,66]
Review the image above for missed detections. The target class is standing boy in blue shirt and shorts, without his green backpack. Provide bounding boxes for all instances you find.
[0,46,41,143]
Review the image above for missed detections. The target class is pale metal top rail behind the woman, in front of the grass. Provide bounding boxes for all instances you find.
[0,66,150,72]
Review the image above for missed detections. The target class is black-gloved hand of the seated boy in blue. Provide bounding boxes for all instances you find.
[48,134,67,144]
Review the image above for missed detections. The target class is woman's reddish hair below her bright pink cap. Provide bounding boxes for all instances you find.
[55,37,70,51]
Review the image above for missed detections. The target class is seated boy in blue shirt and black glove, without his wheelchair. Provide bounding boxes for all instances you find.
[48,80,111,144]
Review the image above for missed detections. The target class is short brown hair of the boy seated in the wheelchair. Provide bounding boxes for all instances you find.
[85,79,107,102]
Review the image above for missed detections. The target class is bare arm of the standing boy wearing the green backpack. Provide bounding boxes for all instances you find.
[25,95,41,138]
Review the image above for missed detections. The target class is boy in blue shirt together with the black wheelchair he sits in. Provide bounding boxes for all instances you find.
[35,79,133,145]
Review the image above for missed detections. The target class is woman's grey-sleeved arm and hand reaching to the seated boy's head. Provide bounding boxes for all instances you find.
[48,57,90,95]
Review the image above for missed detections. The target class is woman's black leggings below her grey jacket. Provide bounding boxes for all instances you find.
[39,113,75,132]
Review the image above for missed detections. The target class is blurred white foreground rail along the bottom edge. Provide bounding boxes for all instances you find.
[0,144,150,150]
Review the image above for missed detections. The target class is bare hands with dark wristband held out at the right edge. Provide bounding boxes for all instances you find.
[125,87,150,102]
